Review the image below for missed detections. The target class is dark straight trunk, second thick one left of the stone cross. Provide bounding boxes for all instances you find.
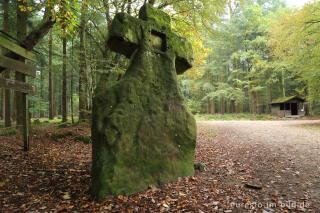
[62,36,67,122]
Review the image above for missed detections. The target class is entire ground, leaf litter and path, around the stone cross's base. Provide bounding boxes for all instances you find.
[0,120,320,213]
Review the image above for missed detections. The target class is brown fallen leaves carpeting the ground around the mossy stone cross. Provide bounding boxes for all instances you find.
[0,120,319,213]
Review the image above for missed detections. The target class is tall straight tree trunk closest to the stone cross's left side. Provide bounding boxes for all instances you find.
[79,5,87,120]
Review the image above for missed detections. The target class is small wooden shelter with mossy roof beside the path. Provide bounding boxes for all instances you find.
[271,96,305,117]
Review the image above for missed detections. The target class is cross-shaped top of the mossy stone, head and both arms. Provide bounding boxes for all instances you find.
[108,4,193,74]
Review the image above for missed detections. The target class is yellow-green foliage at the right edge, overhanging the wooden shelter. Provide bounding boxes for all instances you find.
[270,2,320,102]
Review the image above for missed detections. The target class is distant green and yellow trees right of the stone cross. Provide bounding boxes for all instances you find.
[182,0,320,113]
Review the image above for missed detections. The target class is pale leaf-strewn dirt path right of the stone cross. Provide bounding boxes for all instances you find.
[197,120,320,212]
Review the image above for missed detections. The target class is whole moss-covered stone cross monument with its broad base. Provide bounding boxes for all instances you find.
[91,3,196,200]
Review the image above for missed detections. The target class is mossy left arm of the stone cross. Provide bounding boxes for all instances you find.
[107,13,142,58]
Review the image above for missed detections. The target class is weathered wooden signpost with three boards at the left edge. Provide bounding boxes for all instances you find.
[0,34,36,151]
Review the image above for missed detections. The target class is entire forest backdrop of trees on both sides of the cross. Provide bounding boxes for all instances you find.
[0,0,320,123]
